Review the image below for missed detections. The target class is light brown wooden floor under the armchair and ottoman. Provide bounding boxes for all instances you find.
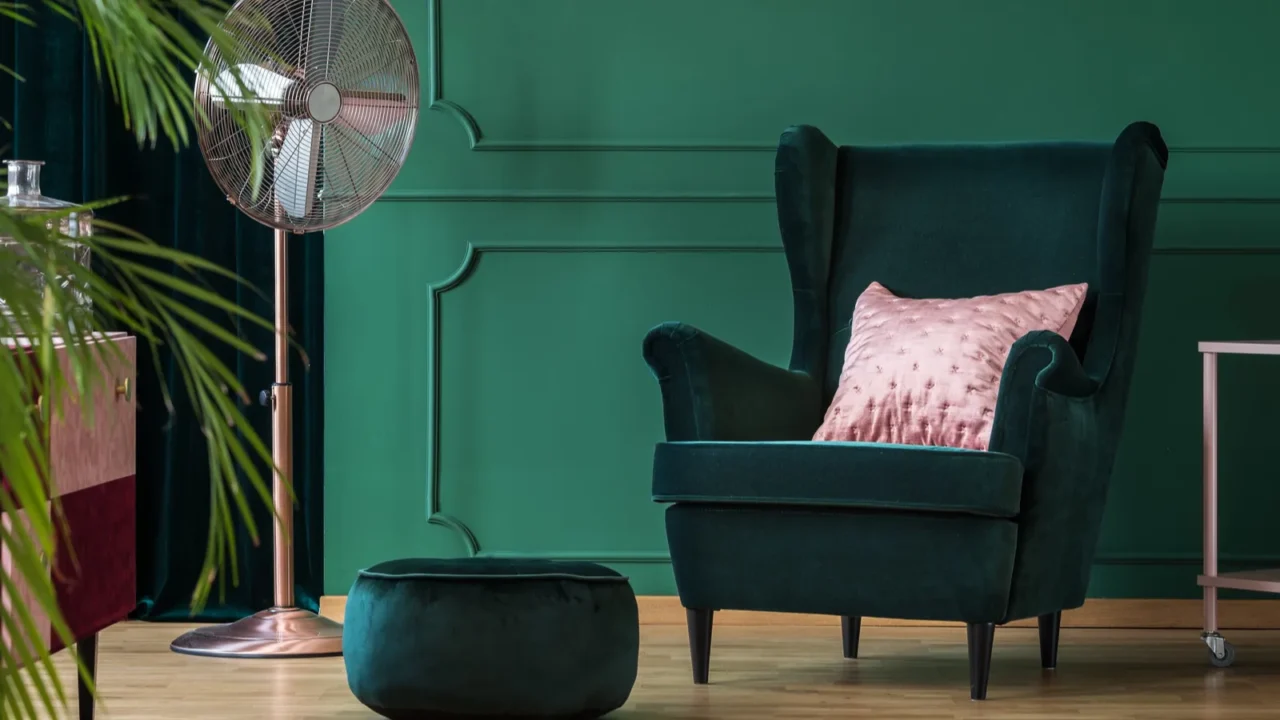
[22,623,1280,720]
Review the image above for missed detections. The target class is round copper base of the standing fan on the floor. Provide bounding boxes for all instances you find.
[169,607,342,657]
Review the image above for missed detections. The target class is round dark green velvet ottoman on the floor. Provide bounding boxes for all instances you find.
[342,557,640,720]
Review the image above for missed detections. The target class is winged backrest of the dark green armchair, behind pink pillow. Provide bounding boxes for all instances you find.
[774,123,1167,401]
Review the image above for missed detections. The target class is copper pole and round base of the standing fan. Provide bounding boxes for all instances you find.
[169,229,342,657]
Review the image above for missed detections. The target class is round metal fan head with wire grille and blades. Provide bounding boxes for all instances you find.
[195,0,419,233]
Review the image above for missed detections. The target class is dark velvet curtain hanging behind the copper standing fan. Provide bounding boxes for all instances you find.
[0,8,324,621]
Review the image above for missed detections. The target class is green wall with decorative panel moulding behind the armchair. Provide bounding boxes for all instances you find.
[324,0,1280,597]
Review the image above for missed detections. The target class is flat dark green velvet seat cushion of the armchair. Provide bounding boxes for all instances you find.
[653,442,1023,518]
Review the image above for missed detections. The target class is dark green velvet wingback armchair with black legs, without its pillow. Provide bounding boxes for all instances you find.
[644,123,1169,700]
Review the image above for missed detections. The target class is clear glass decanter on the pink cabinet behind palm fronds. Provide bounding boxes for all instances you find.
[0,160,93,313]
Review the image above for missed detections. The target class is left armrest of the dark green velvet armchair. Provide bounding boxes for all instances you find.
[644,323,823,441]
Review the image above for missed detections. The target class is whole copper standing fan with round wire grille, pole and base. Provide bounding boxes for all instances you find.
[172,0,419,657]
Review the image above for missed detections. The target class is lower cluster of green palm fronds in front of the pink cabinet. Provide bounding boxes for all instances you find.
[0,210,292,717]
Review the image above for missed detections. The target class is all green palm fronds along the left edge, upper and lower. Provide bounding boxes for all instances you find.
[0,0,307,720]
